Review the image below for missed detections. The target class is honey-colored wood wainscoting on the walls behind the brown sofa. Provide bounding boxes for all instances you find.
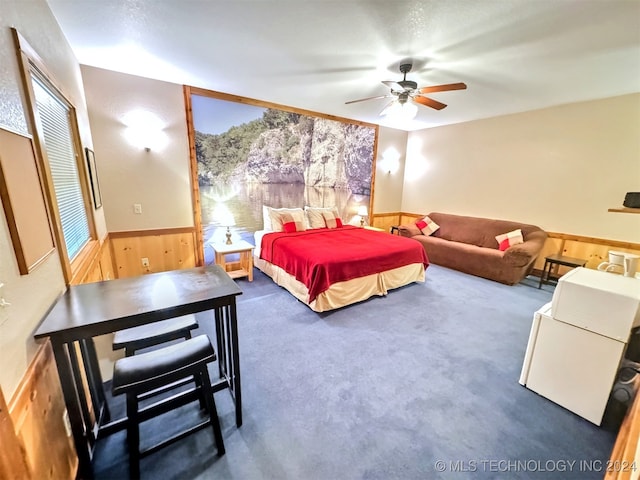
[372,212,640,276]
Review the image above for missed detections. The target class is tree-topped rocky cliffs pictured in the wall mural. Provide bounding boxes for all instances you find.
[196,109,375,195]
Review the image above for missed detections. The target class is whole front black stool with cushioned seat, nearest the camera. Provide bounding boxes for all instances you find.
[112,335,225,478]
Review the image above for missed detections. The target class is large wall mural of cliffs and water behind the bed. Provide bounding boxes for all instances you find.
[191,95,376,251]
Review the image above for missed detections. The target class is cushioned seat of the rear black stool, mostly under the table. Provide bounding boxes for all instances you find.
[113,315,198,357]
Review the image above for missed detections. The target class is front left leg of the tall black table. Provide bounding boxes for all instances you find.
[51,339,93,479]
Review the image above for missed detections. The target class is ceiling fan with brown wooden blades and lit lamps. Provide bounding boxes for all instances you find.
[345,63,467,118]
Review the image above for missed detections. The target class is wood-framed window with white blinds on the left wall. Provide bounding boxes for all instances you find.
[11,28,100,284]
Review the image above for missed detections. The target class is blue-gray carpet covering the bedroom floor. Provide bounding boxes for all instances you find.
[94,265,617,480]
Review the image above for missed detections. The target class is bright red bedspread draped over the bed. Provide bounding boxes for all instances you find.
[260,226,429,303]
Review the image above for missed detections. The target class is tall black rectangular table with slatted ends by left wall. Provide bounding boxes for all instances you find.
[34,265,242,478]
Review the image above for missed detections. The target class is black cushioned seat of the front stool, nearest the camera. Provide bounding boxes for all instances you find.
[112,335,216,395]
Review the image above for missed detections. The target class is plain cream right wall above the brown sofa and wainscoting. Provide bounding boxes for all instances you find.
[402,94,640,242]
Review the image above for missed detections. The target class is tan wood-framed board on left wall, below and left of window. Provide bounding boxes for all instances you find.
[0,127,55,275]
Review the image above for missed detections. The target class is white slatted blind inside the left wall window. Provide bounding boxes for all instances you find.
[31,76,90,261]
